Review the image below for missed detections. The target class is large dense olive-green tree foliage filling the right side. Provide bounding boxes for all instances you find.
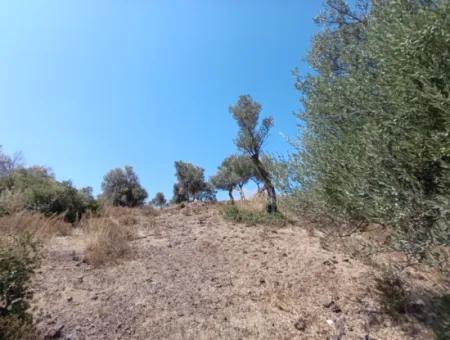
[288,0,450,259]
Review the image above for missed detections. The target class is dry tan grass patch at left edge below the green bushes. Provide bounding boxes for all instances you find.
[0,210,72,239]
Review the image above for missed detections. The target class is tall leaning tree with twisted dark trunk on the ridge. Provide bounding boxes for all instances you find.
[230,95,278,213]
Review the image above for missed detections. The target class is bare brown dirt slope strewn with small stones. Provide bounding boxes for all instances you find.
[32,205,446,340]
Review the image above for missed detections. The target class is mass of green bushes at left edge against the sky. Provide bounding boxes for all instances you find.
[0,167,95,222]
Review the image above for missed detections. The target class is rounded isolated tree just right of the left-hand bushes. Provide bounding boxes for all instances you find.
[102,166,147,207]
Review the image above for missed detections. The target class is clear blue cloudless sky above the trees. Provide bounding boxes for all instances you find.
[0,0,322,197]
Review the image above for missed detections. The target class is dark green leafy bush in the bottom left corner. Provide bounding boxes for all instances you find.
[0,234,39,339]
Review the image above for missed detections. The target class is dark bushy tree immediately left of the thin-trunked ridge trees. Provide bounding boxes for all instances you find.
[174,161,208,201]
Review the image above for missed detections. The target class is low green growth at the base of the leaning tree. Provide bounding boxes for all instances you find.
[223,205,287,227]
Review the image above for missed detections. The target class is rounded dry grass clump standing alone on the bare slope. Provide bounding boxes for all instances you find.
[83,217,135,267]
